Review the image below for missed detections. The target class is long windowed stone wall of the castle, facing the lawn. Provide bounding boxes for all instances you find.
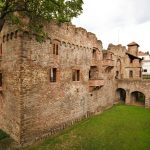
[13,23,114,143]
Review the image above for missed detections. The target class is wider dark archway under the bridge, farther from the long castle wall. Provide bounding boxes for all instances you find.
[131,91,145,105]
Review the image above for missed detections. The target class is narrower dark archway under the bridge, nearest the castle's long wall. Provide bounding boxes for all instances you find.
[116,88,126,103]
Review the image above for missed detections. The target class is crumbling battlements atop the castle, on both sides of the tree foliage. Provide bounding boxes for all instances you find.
[2,21,102,50]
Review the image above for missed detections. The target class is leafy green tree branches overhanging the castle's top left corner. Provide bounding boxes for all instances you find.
[0,0,83,40]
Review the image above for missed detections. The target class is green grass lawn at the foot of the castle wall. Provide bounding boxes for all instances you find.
[26,105,150,150]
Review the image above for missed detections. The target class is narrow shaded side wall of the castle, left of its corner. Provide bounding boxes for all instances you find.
[0,28,22,142]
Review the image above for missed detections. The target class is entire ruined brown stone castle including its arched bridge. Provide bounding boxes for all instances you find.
[0,22,150,144]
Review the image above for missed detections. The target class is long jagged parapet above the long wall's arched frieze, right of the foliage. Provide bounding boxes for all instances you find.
[45,21,102,48]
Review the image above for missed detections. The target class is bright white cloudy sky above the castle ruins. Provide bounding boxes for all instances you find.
[73,0,150,51]
